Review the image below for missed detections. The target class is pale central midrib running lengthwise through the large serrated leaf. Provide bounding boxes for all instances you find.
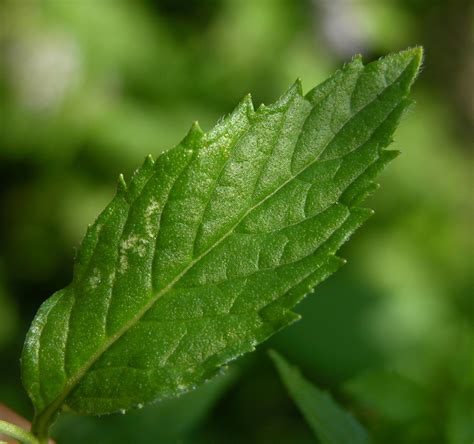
[35,63,411,424]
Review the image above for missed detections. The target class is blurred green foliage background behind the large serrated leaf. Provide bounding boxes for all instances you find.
[0,0,474,444]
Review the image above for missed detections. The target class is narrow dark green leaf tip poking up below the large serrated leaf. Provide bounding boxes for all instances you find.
[269,350,368,444]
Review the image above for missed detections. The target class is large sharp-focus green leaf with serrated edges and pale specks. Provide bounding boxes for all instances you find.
[22,48,422,436]
